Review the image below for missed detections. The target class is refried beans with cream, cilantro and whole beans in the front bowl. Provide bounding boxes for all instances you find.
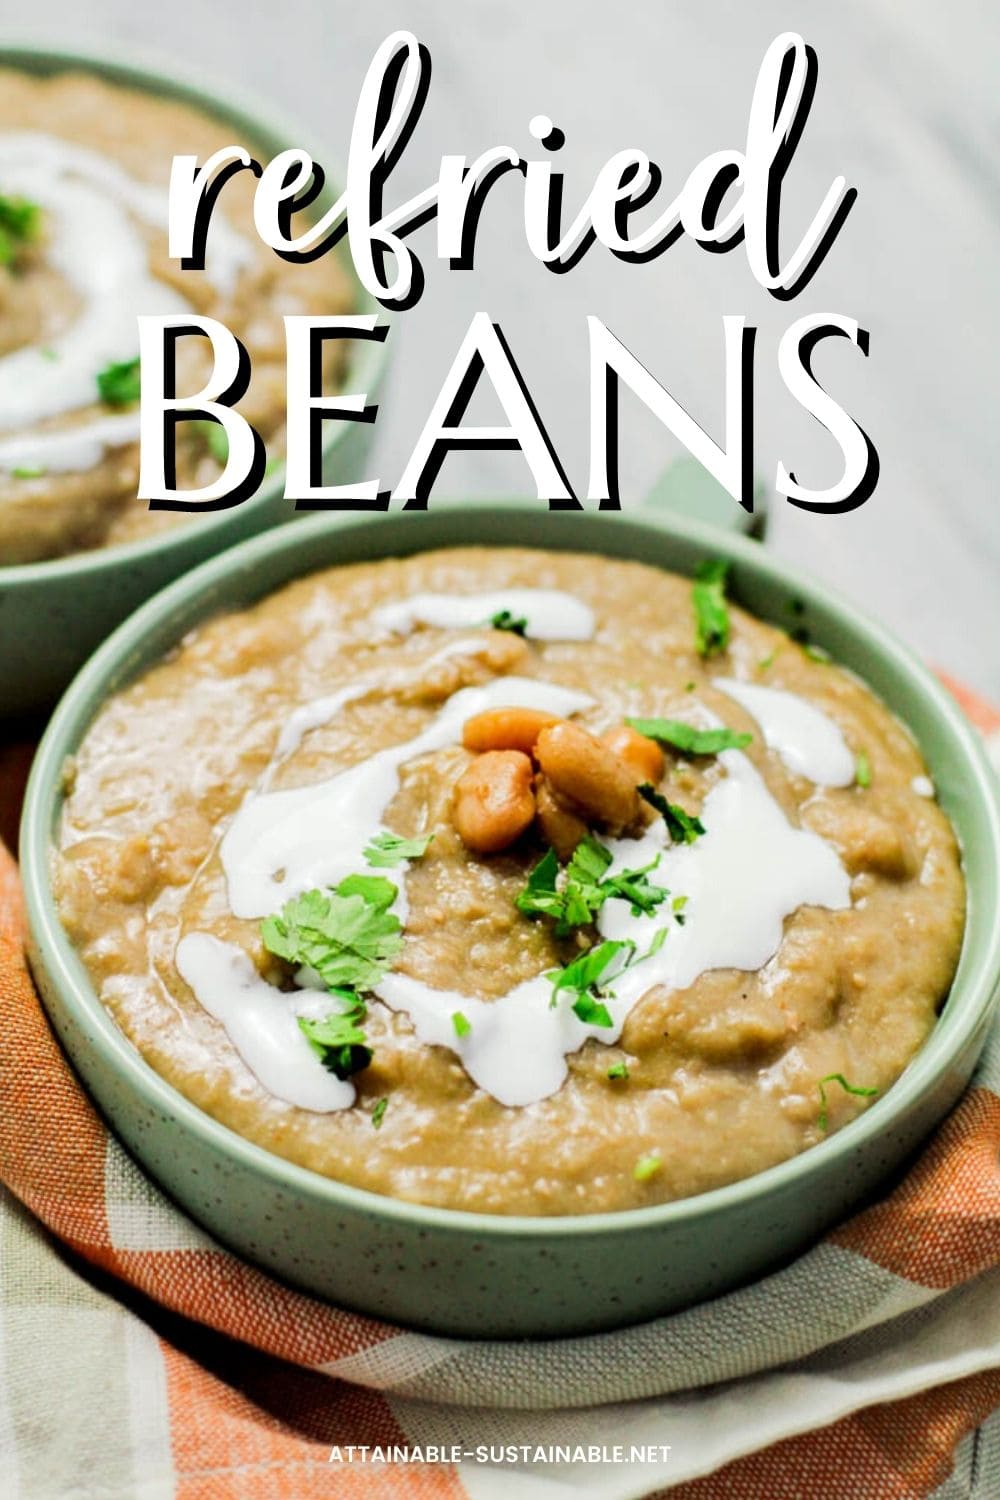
[55,548,964,1214]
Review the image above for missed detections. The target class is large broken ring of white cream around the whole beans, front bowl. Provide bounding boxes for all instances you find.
[177,663,850,1110]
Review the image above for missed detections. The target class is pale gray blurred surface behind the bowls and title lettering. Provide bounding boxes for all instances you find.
[9,0,1000,698]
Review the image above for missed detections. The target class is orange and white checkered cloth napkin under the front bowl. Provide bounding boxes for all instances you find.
[0,684,1000,1500]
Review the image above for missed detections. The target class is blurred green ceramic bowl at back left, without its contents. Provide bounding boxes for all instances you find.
[0,44,388,719]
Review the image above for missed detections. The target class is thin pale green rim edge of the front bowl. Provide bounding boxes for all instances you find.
[21,500,1000,1241]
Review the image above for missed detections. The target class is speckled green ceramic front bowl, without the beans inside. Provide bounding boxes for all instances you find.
[21,503,1000,1337]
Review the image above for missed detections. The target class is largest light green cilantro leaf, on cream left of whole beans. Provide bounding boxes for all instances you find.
[261,875,403,990]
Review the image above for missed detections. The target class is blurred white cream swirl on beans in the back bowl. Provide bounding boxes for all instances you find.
[0,131,252,473]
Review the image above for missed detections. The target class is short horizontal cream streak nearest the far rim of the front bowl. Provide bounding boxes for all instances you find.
[372,588,594,641]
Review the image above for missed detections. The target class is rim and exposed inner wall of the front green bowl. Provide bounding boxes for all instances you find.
[21,501,1000,1238]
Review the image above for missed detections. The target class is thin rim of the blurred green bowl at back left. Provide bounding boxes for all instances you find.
[0,35,390,590]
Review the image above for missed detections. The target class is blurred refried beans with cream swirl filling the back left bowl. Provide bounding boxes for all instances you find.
[0,69,351,564]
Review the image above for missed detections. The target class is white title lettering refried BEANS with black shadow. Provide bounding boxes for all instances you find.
[139,32,879,513]
